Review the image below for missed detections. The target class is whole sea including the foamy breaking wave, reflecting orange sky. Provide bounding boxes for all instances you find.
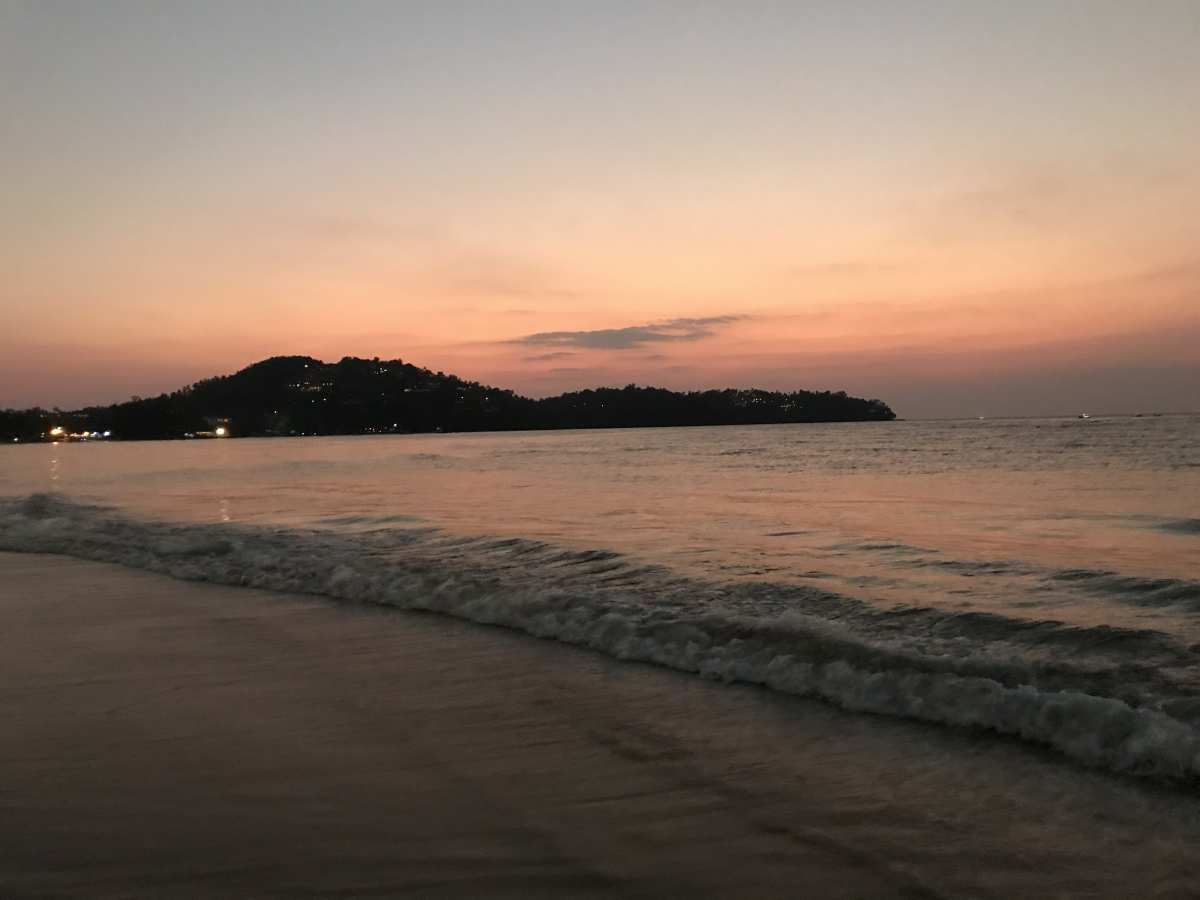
[0,415,1200,784]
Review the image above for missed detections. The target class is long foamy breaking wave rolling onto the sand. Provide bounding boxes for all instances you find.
[0,494,1200,781]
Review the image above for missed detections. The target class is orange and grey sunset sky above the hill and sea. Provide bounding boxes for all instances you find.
[0,0,1200,418]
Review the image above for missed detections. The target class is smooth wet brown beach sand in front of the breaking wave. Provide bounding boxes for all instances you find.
[0,553,1195,898]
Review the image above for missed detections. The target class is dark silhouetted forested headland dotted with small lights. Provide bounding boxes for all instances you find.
[0,356,895,443]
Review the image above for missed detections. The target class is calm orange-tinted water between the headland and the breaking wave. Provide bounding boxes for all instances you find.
[0,416,1200,632]
